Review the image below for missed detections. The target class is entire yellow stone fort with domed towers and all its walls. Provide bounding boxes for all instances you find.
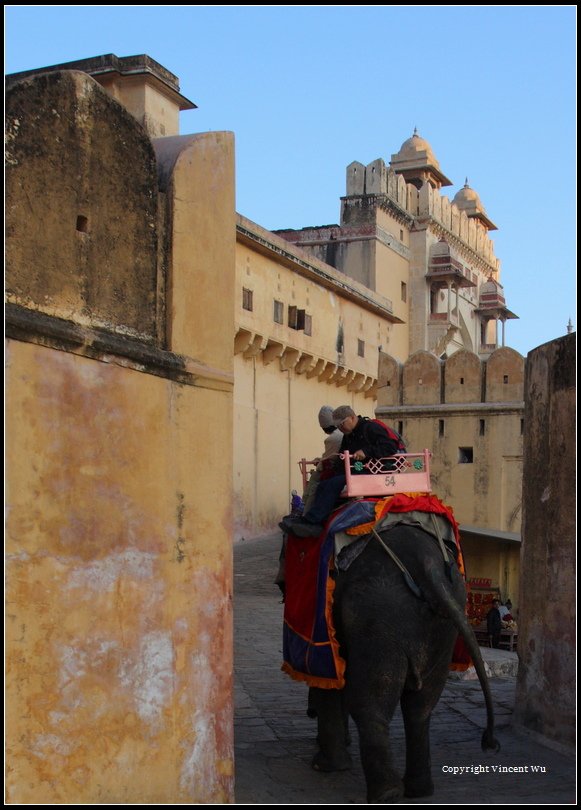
[6,55,574,803]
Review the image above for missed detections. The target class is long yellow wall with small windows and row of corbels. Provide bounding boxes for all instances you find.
[234,217,394,540]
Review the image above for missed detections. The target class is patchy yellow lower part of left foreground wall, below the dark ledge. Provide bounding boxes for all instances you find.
[6,340,233,804]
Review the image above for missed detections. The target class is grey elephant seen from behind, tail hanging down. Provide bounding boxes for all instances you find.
[309,524,500,803]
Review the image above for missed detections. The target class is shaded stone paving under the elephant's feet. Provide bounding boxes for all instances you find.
[234,534,576,805]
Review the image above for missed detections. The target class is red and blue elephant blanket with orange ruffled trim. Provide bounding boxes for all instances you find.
[282,494,470,689]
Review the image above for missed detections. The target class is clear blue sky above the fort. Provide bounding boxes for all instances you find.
[4,5,577,355]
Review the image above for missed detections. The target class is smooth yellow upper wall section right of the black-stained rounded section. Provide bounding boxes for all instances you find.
[167,132,236,372]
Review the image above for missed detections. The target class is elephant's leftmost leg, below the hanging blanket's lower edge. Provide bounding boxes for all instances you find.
[309,688,352,771]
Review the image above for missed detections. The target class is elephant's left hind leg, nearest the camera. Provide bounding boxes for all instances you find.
[347,649,407,804]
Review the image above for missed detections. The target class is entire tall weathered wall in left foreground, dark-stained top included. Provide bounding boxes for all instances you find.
[6,66,235,804]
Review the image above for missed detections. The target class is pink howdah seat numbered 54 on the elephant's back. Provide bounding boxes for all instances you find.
[299,450,432,498]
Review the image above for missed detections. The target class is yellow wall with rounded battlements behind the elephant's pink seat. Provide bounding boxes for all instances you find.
[377,348,524,605]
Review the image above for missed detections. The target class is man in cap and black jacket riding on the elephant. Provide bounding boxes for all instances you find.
[279,405,401,537]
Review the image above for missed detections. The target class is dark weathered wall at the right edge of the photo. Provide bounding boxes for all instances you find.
[514,334,576,746]
